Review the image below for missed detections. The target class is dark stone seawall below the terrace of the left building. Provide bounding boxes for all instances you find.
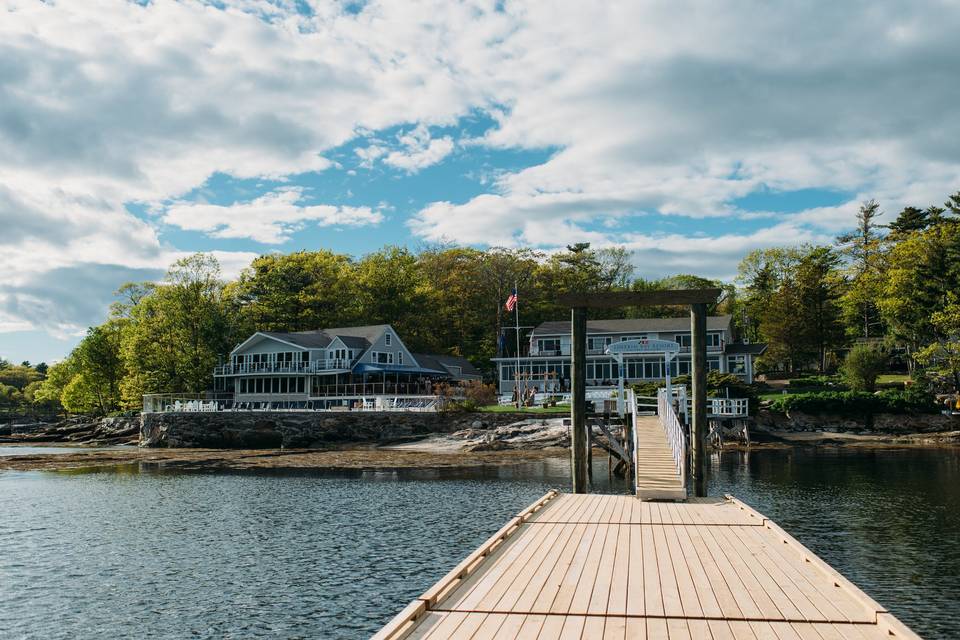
[140,411,529,449]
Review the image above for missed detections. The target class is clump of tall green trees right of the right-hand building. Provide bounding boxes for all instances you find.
[736,192,960,389]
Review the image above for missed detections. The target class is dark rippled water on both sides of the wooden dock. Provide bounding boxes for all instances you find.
[0,449,960,639]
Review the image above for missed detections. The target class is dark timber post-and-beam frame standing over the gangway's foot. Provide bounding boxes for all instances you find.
[558,289,721,496]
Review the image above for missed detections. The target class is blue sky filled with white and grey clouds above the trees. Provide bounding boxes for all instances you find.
[0,0,960,362]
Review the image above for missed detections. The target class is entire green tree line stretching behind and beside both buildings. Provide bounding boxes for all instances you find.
[0,192,960,413]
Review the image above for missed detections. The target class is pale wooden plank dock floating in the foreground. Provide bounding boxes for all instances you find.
[374,491,917,640]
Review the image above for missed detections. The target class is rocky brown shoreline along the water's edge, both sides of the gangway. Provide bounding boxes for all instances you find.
[0,410,960,471]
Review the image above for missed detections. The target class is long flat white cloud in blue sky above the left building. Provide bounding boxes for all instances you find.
[162,187,383,244]
